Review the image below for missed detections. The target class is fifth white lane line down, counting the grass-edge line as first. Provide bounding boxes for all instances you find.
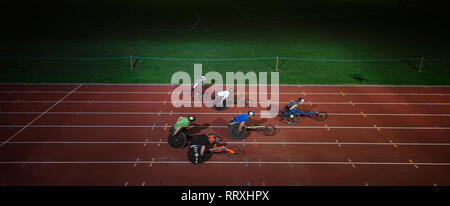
[0,125,450,130]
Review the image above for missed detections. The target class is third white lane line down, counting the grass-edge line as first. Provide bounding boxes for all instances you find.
[0,100,450,106]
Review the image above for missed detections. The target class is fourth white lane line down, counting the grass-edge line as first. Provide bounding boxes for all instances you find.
[0,112,450,117]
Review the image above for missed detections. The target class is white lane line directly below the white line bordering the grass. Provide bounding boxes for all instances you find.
[0,90,450,96]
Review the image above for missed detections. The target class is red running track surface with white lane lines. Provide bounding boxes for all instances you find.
[0,84,450,186]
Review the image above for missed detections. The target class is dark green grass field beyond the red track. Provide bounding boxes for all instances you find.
[0,0,450,85]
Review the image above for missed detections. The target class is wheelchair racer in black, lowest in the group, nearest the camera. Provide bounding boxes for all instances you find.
[188,134,217,164]
